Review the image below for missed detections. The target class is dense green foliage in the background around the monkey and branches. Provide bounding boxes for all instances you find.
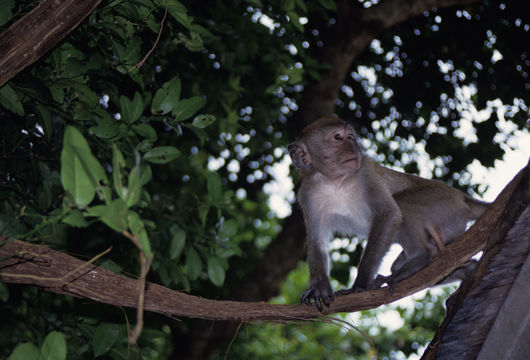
[0,0,529,358]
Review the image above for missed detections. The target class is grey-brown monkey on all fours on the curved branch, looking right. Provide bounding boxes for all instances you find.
[288,117,488,311]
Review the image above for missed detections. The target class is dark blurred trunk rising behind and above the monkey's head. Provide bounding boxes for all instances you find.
[292,0,479,132]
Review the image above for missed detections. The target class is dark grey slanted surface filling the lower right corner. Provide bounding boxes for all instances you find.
[423,160,530,360]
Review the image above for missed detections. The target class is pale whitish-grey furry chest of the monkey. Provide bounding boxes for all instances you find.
[313,186,372,237]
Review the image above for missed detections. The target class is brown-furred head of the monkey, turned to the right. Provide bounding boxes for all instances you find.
[287,116,362,178]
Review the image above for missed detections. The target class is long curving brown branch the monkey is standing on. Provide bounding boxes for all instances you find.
[0,162,530,321]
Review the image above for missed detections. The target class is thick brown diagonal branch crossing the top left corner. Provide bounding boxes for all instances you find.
[0,0,101,87]
